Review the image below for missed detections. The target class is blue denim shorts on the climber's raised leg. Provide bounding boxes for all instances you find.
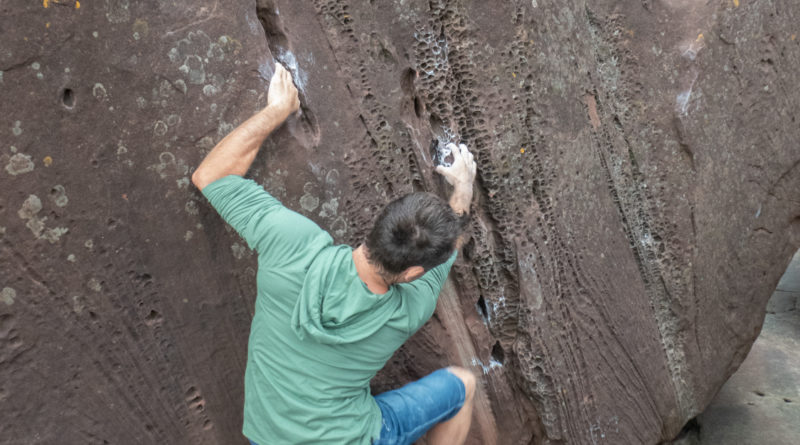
[372,368,466,445]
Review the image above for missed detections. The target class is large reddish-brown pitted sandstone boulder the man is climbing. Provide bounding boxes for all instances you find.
[0,0,800,444]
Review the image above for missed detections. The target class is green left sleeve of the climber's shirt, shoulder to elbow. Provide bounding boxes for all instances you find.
[203,175,333,263]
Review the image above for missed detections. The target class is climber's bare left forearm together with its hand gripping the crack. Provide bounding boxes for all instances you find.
[192,63,300,191]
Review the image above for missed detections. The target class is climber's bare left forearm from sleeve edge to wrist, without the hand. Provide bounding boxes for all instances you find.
[192,104,291,190]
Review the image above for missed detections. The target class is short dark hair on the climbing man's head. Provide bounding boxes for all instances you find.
[366,193,465,275]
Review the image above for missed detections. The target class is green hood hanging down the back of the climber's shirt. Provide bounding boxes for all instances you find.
[291,246,399,344]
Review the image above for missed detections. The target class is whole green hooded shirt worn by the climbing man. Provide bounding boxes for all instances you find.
[203,176,456,445]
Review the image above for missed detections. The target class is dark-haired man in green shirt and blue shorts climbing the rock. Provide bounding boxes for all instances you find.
[192,64,476,445]
